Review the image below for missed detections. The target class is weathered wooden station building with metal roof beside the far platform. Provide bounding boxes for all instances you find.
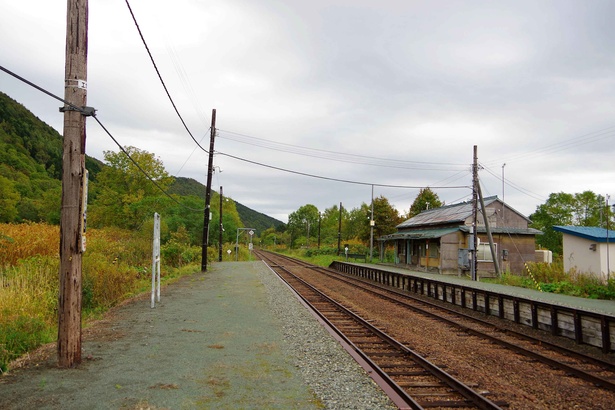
[378,196,542,277]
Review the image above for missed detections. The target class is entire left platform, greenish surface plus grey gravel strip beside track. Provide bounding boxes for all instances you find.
[0,261,395,410]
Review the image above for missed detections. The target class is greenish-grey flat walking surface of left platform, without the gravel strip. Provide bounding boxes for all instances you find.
[0,263,322,410]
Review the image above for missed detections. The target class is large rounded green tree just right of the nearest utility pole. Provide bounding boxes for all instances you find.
[88,147,173,229]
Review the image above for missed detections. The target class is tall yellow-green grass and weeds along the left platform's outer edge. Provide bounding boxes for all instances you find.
[0,224,200,373]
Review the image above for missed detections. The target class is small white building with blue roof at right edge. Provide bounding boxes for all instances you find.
[553,226,615,280]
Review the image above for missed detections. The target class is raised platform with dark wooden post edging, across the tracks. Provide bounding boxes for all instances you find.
[330,261,615,353]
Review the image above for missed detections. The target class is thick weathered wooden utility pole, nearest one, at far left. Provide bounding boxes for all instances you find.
[57,0,88,367]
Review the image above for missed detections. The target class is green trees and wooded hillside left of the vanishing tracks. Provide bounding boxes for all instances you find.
[0,93,284,245]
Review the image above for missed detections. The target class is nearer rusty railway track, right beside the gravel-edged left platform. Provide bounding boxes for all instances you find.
[256,251,505,409]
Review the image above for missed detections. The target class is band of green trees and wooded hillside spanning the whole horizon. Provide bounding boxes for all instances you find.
[0,93,613,254]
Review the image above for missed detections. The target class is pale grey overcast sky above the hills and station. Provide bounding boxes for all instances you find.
[0,0,615,222]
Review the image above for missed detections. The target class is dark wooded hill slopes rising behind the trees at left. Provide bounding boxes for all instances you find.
[0,92,284,232]
